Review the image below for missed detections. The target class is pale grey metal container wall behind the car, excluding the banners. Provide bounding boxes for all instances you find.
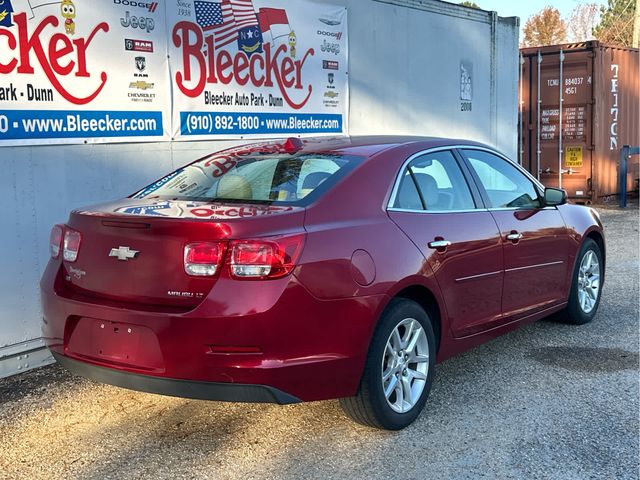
[0,0,519,378]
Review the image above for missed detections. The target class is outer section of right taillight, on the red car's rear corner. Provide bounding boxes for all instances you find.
[229,234,305,279]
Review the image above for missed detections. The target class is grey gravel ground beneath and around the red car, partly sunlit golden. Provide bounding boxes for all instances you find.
[0,209,640,480]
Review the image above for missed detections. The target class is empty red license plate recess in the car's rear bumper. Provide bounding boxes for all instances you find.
[65,317,164,373]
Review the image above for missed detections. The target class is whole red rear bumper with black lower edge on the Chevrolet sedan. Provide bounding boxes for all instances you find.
[41,261,386,403]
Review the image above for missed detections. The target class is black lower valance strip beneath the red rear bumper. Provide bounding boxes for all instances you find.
[53,352,301,405]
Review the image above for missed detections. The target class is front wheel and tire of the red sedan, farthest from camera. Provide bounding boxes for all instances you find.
[556,238,604,325]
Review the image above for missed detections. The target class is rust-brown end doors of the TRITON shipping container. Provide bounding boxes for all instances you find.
[522,49,593,203]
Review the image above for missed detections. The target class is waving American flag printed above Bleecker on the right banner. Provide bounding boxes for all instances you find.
[194,0,258,48]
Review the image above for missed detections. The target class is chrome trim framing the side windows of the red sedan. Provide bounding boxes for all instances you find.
[387,145,544,213]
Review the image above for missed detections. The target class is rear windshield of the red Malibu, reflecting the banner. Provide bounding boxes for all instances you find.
[133,153,362,205]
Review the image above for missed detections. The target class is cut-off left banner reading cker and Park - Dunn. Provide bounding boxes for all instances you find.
[0,0,171,146]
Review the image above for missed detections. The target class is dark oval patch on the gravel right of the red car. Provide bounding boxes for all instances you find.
[529,347,639,373]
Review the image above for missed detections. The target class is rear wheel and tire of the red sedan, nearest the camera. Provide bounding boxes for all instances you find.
[340,298,436,430]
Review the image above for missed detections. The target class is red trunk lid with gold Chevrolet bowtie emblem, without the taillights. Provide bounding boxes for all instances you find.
[63,199,304,308]
